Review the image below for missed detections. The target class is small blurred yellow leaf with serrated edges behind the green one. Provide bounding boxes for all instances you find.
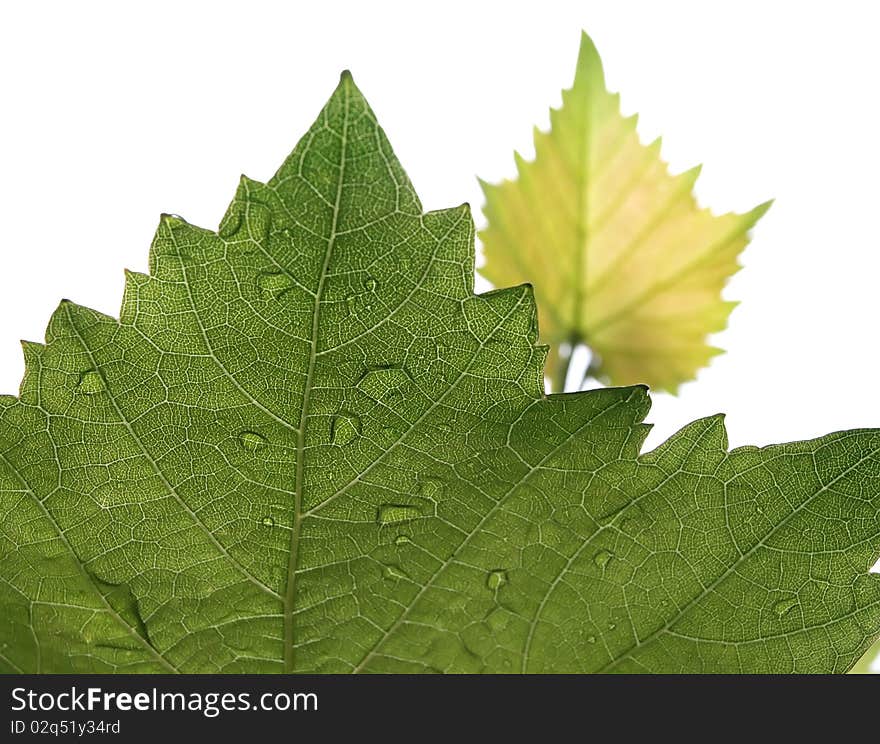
[480,34,770,392]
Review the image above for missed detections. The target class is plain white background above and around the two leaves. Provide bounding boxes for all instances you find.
[0,0,880,454]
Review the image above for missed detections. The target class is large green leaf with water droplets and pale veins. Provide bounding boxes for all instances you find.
[0,75,880,673]
